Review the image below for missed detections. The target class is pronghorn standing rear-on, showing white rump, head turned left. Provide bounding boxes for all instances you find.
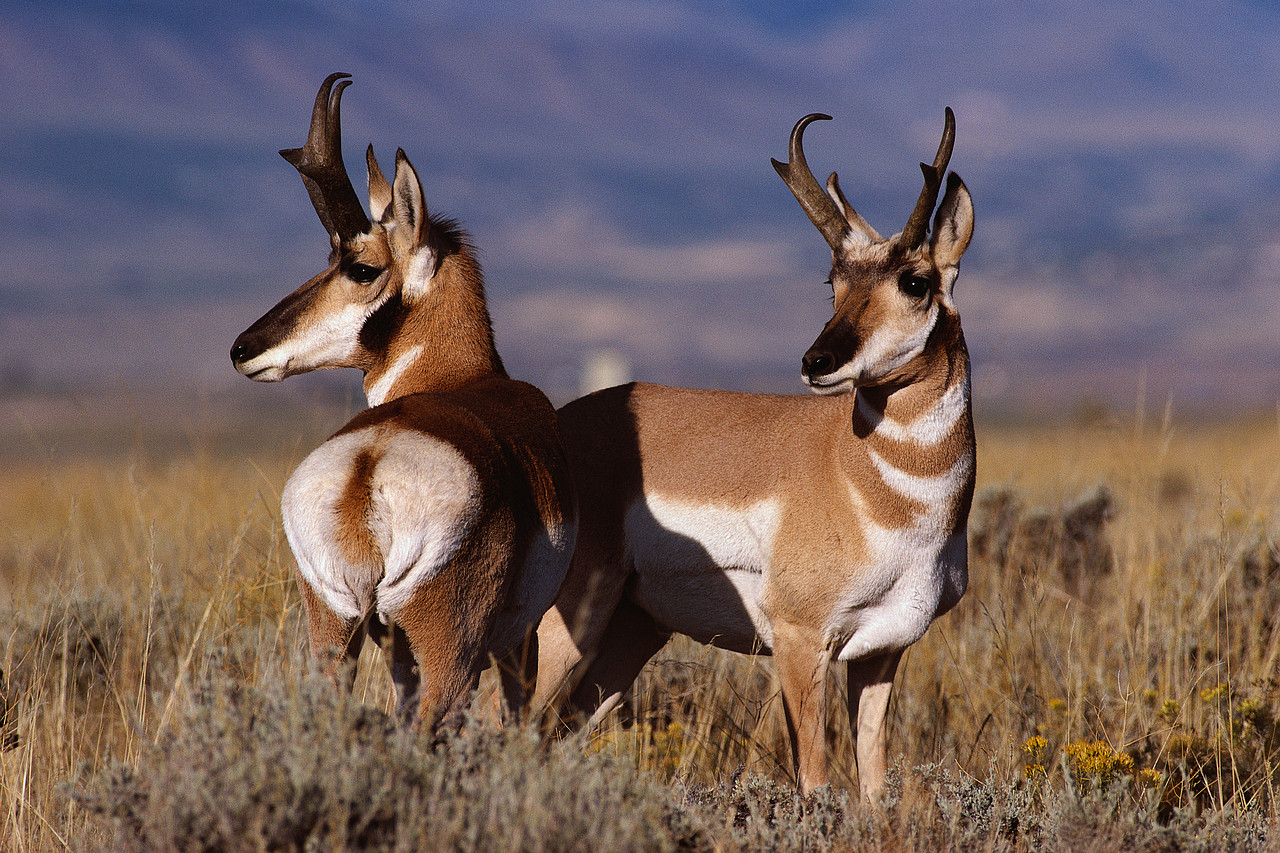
[232,74,577,726]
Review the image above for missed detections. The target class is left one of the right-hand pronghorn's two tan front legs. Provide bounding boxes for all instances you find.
[773,621,828,794]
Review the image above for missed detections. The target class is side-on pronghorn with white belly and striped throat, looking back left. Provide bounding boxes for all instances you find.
[534,109,975,798]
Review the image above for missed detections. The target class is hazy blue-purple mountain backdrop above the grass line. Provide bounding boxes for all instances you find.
[0,0,1280,406]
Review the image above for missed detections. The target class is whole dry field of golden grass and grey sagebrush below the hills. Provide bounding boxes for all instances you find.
[0,394,1280,852]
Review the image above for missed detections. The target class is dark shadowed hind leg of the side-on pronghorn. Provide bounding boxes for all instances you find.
[567,596,671,727]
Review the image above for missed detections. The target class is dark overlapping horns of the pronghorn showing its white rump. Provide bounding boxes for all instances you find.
[280,72,369,240]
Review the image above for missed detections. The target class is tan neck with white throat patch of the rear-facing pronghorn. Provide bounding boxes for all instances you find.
[365,252,507,406]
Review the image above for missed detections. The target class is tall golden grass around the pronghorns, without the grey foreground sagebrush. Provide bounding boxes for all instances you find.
[0,402,1280,850]
